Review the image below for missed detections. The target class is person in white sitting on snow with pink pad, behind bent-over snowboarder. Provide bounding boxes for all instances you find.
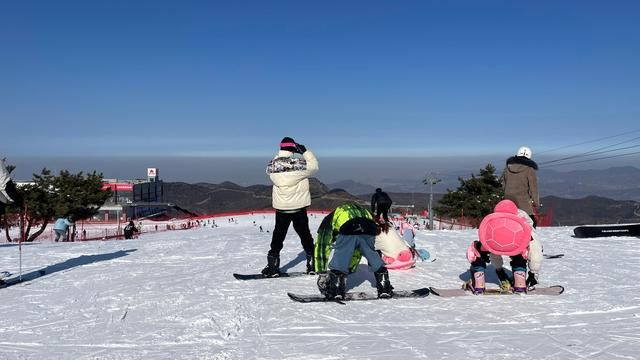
[376,220,416,270]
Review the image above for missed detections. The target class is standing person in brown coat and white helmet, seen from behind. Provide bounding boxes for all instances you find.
[500,146,540,228]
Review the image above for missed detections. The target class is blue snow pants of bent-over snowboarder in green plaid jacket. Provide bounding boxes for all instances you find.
[329,234,384,274]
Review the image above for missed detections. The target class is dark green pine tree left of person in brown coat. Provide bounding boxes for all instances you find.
[434,164,503,226]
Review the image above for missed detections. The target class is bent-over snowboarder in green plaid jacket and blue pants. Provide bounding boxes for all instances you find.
[315,203,393,299]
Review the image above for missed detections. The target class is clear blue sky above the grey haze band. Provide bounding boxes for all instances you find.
[0,0,640,179]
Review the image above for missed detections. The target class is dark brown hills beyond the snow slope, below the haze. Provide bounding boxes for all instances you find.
[164,172,640,226]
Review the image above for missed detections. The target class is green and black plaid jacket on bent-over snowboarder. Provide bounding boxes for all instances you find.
[313,203,373,273]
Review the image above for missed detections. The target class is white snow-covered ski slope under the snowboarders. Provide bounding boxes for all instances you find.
[0,214,640,359]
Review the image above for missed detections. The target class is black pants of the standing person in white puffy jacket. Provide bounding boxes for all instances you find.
[269,209,313,256]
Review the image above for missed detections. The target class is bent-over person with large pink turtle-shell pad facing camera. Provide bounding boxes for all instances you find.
[467,200,532,294]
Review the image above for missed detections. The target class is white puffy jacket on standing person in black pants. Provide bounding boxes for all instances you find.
[269,150,319,210]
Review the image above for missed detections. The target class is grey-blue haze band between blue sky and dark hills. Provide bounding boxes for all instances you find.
[7,155,638,191]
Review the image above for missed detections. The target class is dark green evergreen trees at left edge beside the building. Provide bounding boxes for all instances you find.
[0,168,111,242]
